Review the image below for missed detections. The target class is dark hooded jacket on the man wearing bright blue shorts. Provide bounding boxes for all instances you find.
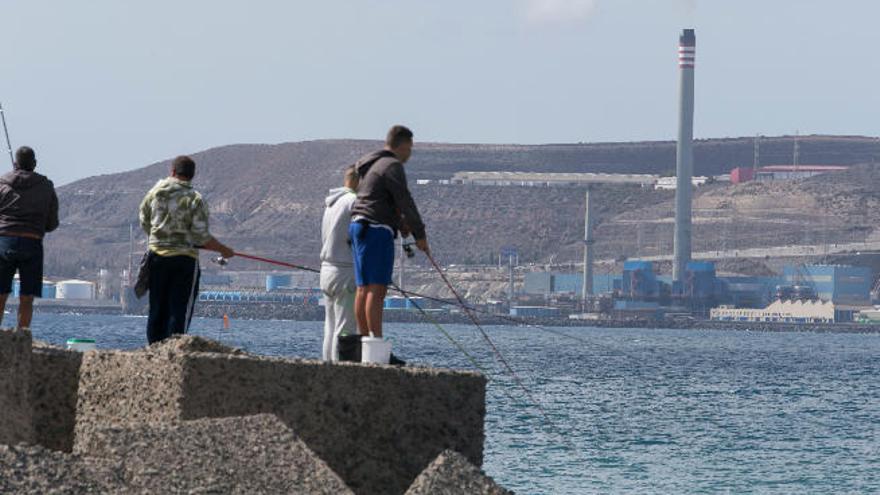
[351,150,425,239]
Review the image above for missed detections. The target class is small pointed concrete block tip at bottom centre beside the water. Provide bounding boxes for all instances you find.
[406,450,513,495]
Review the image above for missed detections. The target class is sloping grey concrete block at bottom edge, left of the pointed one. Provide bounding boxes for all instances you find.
[80,414,353,495]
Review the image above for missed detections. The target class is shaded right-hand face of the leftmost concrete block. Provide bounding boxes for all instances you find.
[30,341,82,452]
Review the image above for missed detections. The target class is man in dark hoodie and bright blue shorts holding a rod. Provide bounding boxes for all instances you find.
[349,125,429,337]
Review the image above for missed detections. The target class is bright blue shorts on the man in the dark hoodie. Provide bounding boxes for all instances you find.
[348,222,394,287]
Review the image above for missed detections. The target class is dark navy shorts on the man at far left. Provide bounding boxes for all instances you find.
[0,235,43,297]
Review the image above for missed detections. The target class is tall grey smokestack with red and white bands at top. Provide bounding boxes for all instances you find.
[672,29,697,282]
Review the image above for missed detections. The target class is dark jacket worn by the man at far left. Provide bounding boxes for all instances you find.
[0,170,58,237]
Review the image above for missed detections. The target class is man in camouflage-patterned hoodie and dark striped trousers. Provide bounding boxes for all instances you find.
[140,156,235,344]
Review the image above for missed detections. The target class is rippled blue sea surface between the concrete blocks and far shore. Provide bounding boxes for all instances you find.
[27,314,880,494]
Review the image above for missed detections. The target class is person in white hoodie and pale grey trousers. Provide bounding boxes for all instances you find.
[321,167,358,361]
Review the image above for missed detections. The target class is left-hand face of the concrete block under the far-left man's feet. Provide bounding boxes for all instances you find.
[0,330,34,444]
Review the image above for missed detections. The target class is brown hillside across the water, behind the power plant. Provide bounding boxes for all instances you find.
[46,136,880,284]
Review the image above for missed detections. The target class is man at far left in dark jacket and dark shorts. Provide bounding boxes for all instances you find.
[0,146,58,328]
